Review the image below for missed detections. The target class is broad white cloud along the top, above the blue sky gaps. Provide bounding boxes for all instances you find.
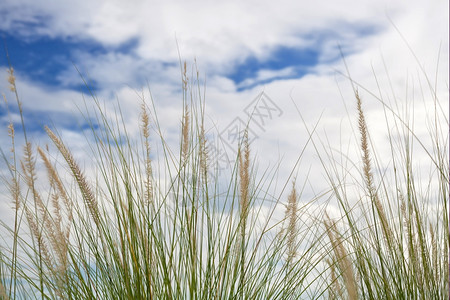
[0,0,422,71]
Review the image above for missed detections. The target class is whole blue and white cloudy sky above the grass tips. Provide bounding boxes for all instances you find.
[0,0,449,225]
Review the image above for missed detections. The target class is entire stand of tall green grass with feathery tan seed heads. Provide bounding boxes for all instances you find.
[0,55,449,299]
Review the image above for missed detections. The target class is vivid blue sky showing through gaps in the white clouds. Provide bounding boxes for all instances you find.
[1,18,378,91]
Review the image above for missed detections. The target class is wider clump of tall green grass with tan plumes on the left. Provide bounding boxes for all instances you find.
[0,60,321,299]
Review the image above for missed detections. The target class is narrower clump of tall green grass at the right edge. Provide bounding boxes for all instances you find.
[318,86,449,299]
